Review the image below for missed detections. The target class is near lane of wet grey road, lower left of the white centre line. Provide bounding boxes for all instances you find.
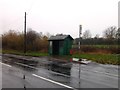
[0,58,72,88]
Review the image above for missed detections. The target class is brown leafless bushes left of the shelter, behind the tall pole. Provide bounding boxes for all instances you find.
[2,29,48,52]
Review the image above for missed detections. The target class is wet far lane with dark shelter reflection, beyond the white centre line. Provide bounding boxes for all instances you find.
[3,57,118,88]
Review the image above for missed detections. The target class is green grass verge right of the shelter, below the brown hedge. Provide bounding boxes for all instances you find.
[72,53,120,65]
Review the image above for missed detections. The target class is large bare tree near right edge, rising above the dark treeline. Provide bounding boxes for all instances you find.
[103,26,117,39]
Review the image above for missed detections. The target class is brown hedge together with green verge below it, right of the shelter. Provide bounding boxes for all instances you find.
[73,45,120,65]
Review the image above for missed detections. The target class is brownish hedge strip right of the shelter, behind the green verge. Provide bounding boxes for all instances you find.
[73,45,120,54]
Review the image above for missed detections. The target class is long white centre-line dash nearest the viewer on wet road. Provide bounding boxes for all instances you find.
[32,74,75,89]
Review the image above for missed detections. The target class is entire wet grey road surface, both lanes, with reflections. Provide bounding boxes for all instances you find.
[2,56,118,89]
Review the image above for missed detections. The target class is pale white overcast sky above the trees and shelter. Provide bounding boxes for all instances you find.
[0,0,119,38]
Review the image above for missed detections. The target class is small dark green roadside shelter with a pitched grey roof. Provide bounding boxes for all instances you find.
[48,34,73,55]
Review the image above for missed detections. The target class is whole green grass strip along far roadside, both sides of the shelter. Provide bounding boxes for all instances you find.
[2,50,120,65]
